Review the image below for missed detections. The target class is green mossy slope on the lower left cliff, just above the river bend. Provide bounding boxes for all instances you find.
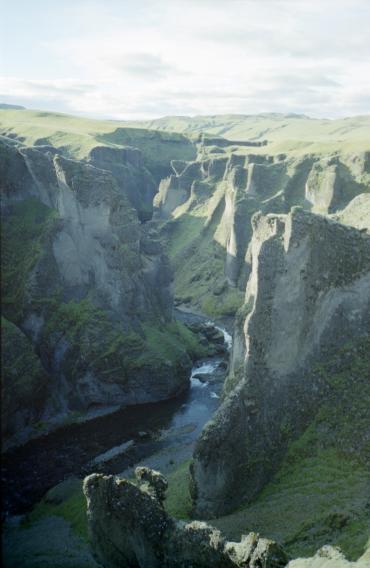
[44,299,206,382]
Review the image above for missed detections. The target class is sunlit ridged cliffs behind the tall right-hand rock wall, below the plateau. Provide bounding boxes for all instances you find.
[155,144,370,314]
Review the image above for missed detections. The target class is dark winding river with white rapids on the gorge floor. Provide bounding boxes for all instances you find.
[2,313,232,514]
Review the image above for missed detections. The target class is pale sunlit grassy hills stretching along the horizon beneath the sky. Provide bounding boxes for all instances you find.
[0,105,370,159]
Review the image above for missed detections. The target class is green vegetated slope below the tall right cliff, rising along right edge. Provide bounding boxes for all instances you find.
[212,337,370,560]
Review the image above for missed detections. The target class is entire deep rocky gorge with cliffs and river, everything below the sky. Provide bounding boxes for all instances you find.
[0,109,370,568]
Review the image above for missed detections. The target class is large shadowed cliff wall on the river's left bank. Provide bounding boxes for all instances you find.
[0,139,198,448]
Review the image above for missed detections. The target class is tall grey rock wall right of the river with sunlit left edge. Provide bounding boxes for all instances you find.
[192,208,370,516]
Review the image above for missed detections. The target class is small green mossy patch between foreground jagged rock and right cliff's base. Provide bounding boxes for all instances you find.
[164,460,192,520]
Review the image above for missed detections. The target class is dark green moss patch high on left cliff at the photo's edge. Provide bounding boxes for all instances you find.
[1,198,57,323]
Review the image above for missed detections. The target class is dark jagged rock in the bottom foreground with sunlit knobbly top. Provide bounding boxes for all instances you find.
[84,468,287,568]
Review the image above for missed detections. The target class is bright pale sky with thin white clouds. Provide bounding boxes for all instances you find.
[0,0,370,120]
